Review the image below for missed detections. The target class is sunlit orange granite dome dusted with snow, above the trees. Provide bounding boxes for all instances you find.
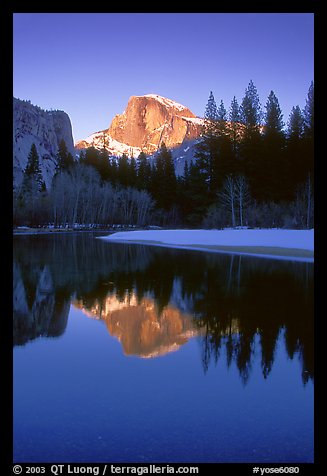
[76,94,203,156]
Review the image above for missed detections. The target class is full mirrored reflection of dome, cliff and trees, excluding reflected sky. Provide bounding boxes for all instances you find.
[13,234,313,383]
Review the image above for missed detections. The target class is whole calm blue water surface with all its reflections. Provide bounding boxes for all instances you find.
[14,233,314,463]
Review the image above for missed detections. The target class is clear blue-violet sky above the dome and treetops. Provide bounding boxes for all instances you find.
[14,13,314,140]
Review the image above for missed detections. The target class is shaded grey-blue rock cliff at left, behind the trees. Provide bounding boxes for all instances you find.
[13,98,75,187]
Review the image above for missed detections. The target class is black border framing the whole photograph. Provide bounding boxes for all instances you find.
[4,0,325,475]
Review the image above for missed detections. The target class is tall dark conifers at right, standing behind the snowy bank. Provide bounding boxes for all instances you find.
[183,81,314,228]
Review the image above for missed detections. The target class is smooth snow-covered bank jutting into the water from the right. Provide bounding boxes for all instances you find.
[101,229,314,262]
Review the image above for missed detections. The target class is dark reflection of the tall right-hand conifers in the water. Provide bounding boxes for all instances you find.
[195,257,313,383]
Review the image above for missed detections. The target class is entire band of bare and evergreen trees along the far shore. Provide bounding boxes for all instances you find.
[14,81,314,228]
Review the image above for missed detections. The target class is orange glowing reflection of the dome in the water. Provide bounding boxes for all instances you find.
[74,294,199,358]
